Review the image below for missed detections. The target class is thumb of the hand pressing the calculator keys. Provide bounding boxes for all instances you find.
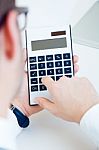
[36,97,54,112]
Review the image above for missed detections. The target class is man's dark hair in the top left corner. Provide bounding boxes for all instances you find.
[0,0,15,26]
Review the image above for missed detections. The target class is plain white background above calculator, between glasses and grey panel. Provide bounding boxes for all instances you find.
[16,0,96,27]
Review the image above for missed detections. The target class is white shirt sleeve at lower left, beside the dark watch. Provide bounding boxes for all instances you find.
[0,110,22,150]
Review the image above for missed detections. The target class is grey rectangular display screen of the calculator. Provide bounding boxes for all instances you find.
[31,37,67,51]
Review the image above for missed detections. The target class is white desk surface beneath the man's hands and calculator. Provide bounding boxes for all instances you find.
[17,44,99,150]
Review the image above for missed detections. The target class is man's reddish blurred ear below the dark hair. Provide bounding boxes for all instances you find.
[4,11,20,59]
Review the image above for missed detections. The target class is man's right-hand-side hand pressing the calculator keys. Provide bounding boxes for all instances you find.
[36,76,99,123]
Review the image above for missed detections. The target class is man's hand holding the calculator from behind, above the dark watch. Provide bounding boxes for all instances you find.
[13,51,79,117]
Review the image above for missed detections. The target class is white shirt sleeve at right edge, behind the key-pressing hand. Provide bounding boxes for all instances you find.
[80,104,99,147]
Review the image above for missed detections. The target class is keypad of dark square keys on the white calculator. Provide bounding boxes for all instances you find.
[29,53,72,92]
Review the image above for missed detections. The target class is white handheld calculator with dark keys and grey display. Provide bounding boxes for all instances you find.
[25,25,74,106]
